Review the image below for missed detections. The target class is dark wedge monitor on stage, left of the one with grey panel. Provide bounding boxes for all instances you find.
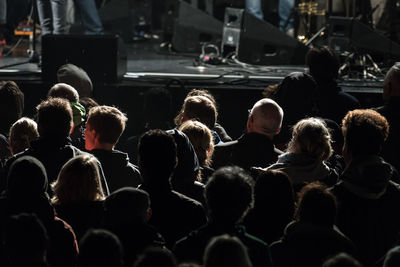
[172,0,223,53]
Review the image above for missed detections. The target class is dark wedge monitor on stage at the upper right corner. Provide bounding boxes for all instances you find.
[328,16,400,58]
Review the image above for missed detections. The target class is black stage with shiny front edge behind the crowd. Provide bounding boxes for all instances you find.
[0,36,383,138]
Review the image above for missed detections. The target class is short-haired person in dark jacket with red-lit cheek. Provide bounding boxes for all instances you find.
[85,106,142,192]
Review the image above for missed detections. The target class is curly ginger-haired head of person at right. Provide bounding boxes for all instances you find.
[342,109,389,156]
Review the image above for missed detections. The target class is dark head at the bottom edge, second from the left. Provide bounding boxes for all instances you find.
[78,229,123,267]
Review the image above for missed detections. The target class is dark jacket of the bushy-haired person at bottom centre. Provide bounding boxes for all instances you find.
[174,223,272,267]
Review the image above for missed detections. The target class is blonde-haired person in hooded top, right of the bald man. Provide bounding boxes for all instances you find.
[267,118,338,191]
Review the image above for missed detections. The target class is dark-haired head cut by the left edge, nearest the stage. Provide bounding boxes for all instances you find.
[0,81,24,135]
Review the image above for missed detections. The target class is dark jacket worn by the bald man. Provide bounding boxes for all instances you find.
[212,133,282,170]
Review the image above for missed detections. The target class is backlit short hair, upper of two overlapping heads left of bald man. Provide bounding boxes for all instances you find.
[175,96,218,129]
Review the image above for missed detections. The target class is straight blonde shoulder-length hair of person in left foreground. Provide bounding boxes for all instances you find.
[51,155,104,204]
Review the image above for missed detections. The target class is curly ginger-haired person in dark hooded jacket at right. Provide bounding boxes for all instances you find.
[332,109,400,267]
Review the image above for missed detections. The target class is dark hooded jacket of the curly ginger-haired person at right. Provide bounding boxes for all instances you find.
[332,156,400,266]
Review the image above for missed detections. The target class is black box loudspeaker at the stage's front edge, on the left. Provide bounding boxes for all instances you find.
[42,34,127,83]
